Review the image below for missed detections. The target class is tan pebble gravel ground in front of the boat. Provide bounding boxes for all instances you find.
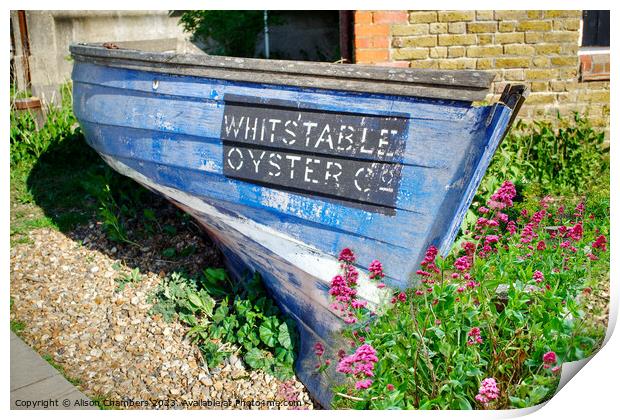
[11,222,313,409]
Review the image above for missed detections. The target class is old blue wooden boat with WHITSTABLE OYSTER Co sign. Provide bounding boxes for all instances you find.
[71,44,525,406]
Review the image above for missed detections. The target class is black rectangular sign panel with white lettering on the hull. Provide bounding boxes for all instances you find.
[221,95,408,209]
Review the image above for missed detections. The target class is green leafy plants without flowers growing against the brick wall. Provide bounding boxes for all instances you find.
[461,113,609,232]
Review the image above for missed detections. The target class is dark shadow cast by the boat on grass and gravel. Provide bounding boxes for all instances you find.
[26,129,222,275]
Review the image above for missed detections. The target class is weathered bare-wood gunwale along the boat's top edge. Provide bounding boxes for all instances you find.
[69,44,495,102]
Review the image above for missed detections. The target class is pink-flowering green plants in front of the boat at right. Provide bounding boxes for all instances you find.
[322,182,609,409]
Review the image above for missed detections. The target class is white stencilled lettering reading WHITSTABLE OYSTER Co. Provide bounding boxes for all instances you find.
[222,110,405,197]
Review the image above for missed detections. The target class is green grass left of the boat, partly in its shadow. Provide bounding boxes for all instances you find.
[10,83,155,246]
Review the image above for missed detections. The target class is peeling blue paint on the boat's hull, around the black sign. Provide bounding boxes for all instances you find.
[73,62,511,405]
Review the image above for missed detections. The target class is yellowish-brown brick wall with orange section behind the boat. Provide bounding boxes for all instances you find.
[354,10,609,135]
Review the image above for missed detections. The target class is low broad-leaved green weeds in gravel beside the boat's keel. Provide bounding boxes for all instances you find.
[150,268,297,379]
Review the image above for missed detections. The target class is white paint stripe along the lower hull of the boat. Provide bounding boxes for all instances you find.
[102,155,391,306]
